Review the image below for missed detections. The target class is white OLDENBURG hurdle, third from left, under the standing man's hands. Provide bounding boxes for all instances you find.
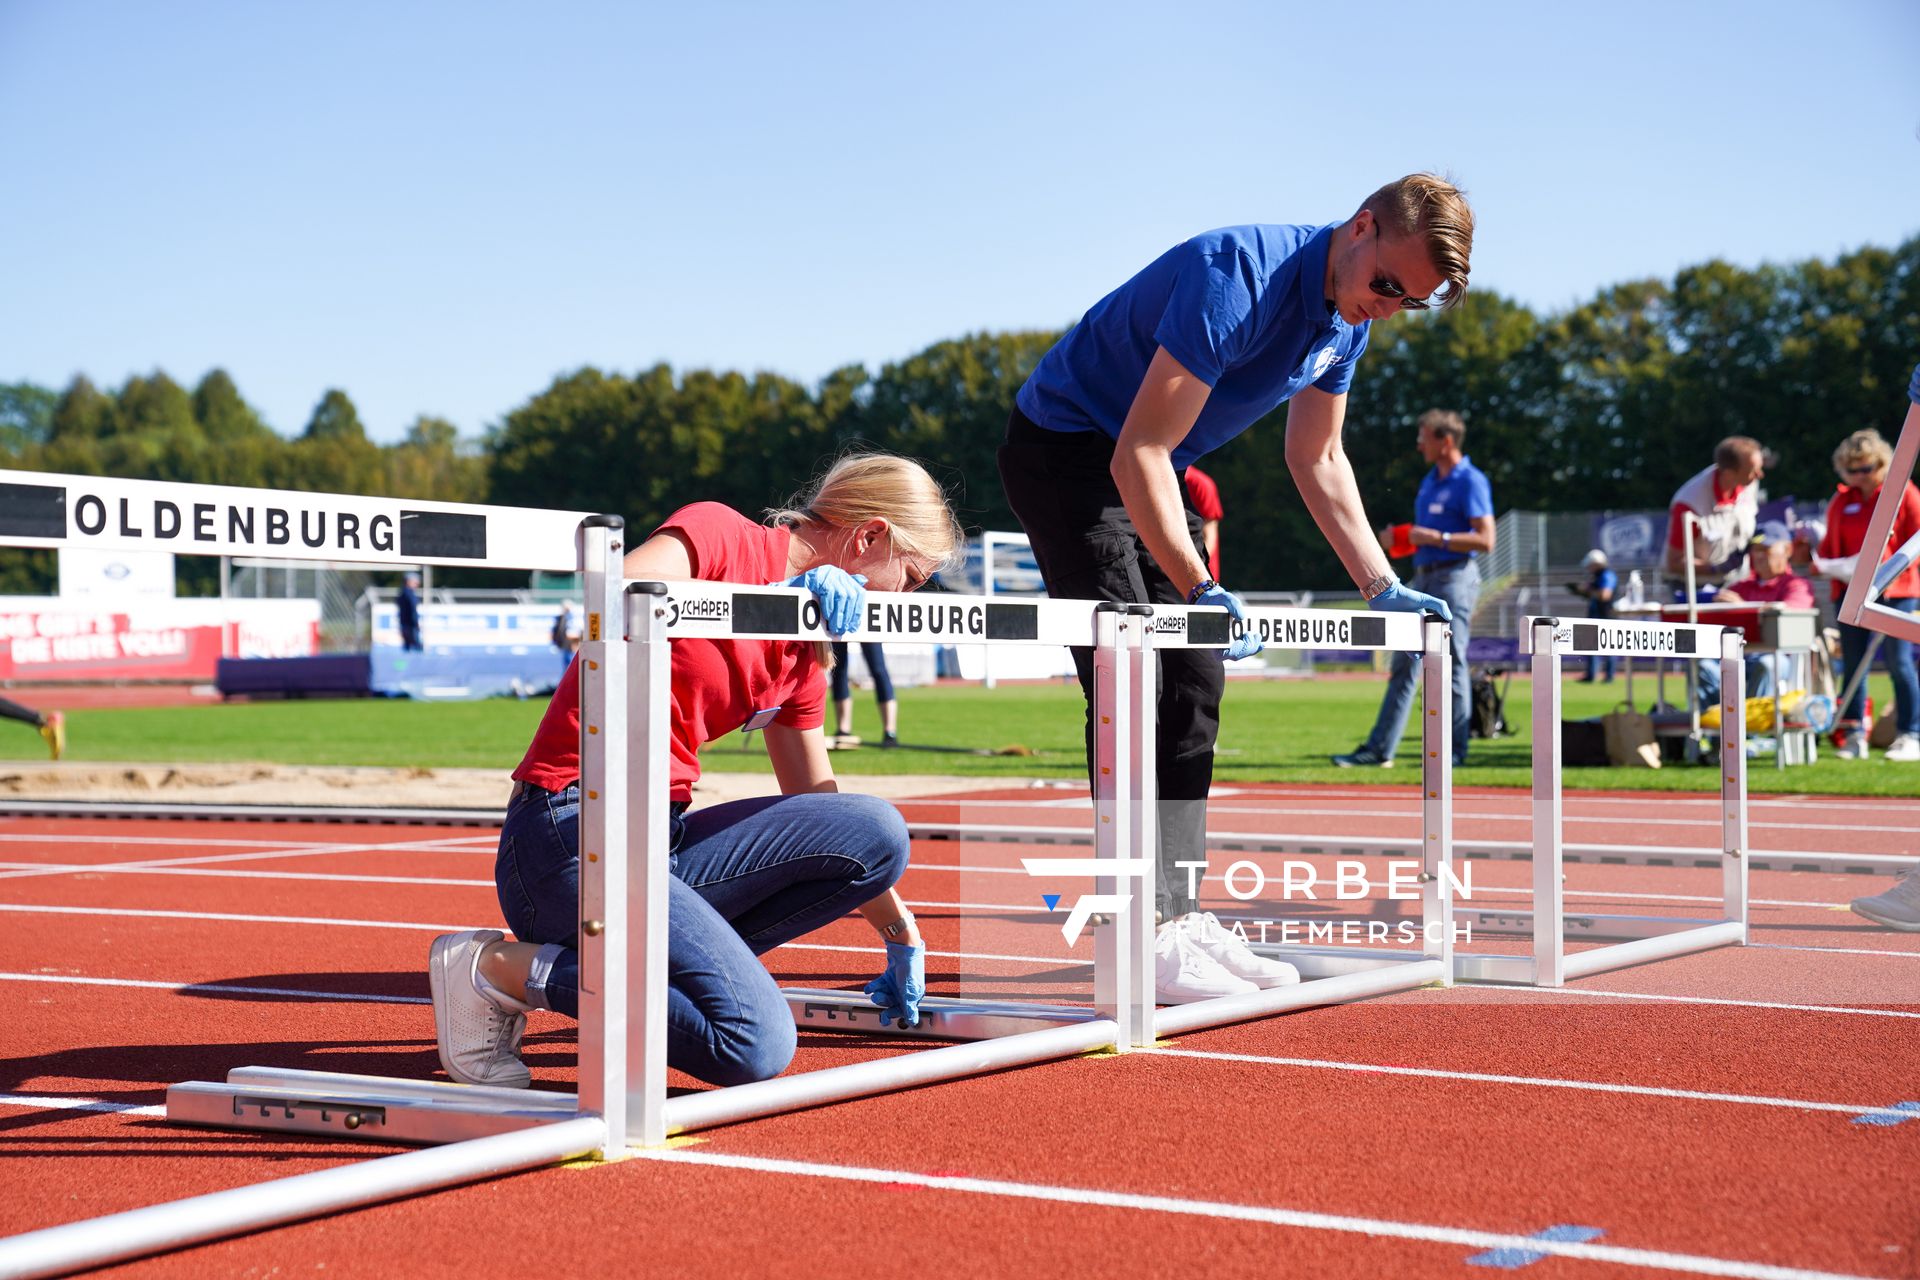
[1135,604,1453,1036]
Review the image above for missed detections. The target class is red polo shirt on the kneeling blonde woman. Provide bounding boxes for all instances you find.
[513,503,826,800]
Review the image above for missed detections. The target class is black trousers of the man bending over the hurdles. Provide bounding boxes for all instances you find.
[1000,409,1227,919]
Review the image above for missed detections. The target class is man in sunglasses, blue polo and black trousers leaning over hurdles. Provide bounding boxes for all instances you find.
[1000,173,1473,1002]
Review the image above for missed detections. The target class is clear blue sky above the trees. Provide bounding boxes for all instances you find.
[0,0,1920,439]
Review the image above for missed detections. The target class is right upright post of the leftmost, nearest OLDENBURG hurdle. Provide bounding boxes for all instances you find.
[574,516,629,1159]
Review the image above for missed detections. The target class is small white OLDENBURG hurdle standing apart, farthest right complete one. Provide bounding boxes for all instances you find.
[1453,616,1747,986]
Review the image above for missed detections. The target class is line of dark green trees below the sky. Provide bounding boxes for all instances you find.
[0,236,1920,593]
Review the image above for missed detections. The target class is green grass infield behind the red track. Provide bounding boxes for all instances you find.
[22,672,1920,796]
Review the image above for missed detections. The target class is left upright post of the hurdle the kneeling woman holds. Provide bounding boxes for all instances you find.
[624,581,674,1146]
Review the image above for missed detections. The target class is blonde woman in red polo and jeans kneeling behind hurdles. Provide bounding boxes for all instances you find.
[428,453,960,1086]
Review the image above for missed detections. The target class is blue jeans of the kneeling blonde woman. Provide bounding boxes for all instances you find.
[493,785,906,1084]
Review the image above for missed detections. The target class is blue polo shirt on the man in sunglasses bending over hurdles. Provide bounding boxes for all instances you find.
[1014,225,1367,468]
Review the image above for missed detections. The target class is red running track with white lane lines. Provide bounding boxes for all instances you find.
[0,787,1920,1276]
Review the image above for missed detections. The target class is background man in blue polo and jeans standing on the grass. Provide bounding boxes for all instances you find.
[1332,409,1494,766]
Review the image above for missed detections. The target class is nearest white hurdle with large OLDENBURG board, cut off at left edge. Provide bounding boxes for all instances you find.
[0,470,628,1276]
